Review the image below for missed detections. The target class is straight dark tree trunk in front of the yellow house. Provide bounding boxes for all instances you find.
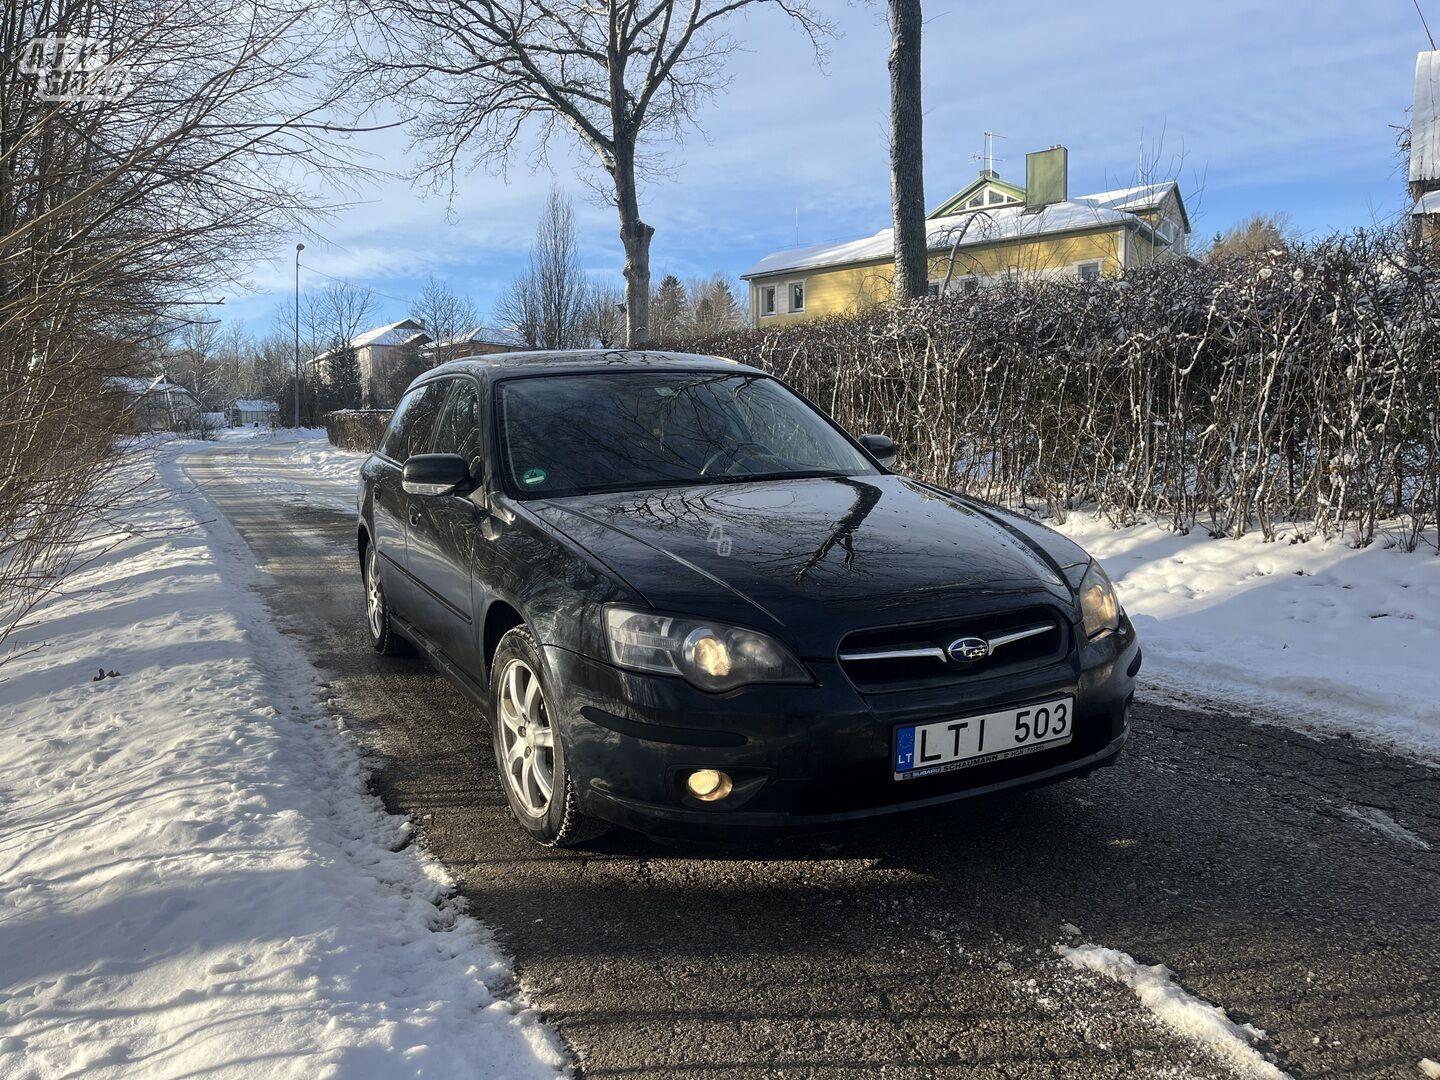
[888,0,930,301]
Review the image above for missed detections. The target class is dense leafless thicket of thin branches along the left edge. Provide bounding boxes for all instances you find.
[0,0,360,659]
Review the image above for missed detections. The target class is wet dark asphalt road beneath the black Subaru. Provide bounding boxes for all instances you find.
[184,446,1440,1077]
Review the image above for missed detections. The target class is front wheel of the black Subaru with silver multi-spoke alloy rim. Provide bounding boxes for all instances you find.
[490,626,609,848]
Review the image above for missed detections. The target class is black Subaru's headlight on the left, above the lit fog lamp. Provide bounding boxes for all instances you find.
[605,608,811,691]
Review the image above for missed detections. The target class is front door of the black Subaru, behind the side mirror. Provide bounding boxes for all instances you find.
[406,376,485,680]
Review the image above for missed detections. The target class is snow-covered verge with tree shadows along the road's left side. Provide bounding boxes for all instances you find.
[0,439,569,1080]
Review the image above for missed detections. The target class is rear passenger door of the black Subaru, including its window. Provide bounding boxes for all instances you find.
[370,383,448,616]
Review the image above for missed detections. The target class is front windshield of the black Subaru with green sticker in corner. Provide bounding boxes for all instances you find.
[500,372,876,497]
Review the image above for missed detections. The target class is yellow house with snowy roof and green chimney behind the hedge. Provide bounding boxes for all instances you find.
[742,147,1189,328]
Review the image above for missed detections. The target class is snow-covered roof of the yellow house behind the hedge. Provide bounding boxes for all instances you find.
[740,198,1151,278]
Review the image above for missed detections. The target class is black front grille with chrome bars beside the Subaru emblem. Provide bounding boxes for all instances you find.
[840,606,1070,694]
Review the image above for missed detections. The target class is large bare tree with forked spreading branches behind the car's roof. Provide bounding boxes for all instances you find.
[341,0,829,344]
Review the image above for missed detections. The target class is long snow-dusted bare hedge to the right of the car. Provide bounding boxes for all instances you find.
[687,232,1440,547]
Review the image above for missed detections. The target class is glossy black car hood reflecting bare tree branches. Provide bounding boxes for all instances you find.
[527,475,1074,657]
